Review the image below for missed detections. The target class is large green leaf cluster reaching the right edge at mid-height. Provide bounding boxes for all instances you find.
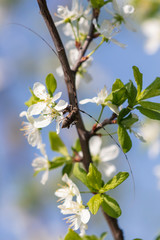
[105,66,160,153]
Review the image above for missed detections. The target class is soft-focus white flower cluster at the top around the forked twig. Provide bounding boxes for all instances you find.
[55,0,134,88]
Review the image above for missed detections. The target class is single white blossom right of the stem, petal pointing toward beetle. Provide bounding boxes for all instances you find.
[79,86,119,115]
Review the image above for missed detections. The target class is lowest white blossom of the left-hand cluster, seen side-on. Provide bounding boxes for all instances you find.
[32,144,50,185]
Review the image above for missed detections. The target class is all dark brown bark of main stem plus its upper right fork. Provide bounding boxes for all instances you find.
[37,0,123,240]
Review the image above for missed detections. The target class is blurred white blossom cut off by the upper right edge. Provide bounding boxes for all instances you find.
[141,19,160,54]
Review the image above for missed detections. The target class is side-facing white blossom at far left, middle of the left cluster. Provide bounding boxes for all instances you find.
[19,111,42,148]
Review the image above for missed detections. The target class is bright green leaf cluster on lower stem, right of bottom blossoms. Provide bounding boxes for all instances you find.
[73,163,129,218]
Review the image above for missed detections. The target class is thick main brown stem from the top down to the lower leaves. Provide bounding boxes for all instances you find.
[37,0,92,171]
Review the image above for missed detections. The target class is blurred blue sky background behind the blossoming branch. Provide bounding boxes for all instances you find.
[0,0,160,240]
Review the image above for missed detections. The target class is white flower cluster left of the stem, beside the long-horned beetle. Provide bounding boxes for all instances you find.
[20,82,68,184]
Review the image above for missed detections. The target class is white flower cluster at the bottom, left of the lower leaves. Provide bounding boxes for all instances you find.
[55,174,90,236]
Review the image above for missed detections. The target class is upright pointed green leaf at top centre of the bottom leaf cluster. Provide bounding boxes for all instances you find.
[87,163,103,191]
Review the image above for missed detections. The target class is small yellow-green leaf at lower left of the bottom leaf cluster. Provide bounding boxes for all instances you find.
[87,194,103,215]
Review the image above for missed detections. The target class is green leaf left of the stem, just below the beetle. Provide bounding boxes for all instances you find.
[49,132,69,156]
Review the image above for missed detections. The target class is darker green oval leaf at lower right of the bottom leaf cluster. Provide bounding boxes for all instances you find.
[102,194,121,218]
